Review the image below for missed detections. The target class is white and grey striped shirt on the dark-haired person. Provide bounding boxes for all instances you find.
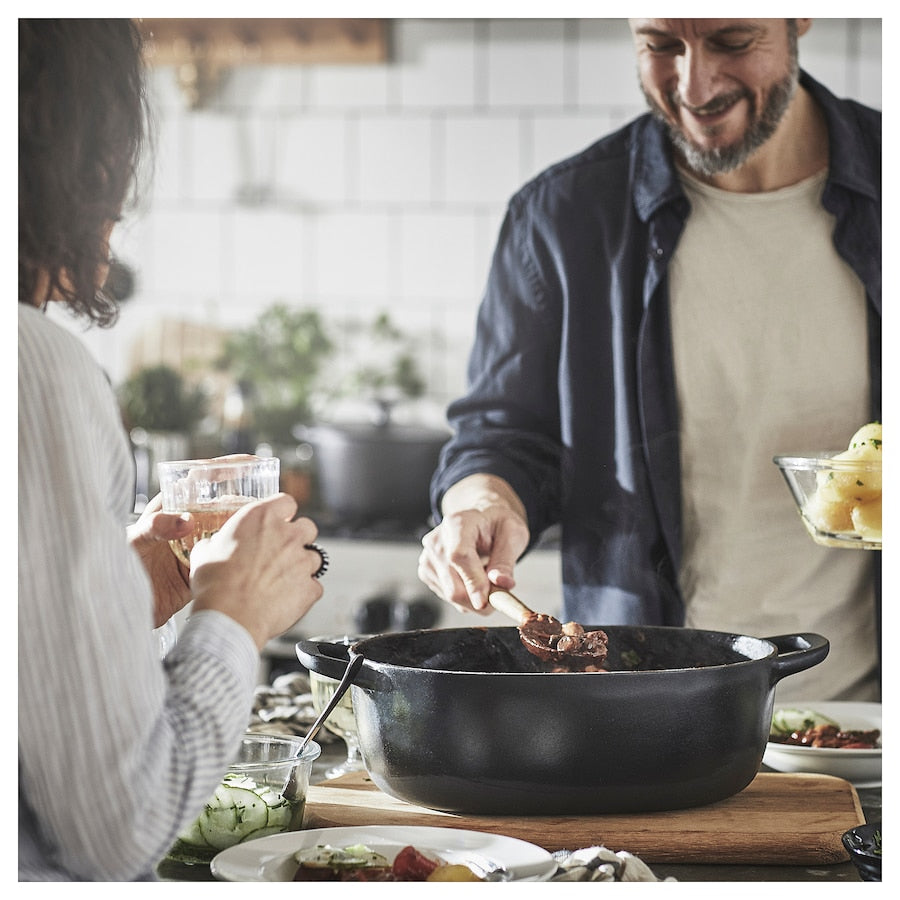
[18,311,258,881]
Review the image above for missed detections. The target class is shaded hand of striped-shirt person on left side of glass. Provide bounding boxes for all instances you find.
[126,495,193,628]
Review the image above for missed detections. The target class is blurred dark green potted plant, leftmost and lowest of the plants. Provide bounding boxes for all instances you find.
[117,365,207,434]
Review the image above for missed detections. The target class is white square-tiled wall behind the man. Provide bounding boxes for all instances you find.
[58,19,881,408]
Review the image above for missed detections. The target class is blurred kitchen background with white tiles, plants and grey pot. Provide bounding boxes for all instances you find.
[47,18,882,671]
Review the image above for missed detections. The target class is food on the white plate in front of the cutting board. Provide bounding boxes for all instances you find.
[294,844,483,882]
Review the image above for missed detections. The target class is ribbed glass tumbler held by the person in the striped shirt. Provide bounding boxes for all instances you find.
[157,454,281,566]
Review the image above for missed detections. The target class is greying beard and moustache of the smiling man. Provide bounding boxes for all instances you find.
[641,42,799,176]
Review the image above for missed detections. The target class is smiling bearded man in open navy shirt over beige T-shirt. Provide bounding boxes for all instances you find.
[419,19,881,700]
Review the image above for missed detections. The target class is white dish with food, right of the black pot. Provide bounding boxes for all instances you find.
[763,700,881,788]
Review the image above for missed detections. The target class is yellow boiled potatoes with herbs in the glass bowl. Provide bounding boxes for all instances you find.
[806,422,881,540]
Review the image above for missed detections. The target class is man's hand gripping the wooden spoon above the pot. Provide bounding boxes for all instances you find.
[418,475,530,613]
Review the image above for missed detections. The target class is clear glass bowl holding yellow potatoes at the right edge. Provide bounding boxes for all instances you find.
[773,451,881,550]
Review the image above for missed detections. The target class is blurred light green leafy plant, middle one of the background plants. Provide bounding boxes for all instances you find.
[218,303,334,443]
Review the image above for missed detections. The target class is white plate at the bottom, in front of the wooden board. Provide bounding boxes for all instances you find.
[210,825,556,881]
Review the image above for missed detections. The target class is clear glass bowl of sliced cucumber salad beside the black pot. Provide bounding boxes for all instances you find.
[167,732,322,865]
